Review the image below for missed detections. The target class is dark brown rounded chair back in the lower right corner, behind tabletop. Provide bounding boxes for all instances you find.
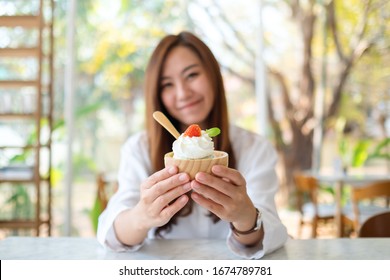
[358,211,390,237]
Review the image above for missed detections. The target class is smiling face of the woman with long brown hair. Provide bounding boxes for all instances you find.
[160,46,215,129]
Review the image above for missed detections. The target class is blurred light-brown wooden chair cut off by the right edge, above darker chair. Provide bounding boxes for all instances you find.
[344,181,390,234]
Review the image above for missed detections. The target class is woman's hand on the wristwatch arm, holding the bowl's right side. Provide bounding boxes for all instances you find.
[191,165,256,231]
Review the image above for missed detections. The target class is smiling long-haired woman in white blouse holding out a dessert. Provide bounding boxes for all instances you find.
[98,32,287,258]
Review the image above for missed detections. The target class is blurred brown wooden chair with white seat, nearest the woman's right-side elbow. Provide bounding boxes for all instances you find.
[293,173,336,238]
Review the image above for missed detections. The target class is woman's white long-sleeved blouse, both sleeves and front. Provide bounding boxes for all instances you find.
[97,126,288,259]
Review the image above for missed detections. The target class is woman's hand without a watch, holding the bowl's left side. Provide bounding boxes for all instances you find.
[134,166,191,230]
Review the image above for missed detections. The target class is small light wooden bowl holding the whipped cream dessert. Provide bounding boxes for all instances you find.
[164,151,229,180]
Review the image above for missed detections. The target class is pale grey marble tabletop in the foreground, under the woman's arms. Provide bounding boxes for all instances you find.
[0,237,390,260]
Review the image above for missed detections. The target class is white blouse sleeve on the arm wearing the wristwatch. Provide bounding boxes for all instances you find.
[227,127,288,259]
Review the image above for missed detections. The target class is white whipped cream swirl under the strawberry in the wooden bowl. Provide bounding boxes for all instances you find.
[172,130,214,159]
